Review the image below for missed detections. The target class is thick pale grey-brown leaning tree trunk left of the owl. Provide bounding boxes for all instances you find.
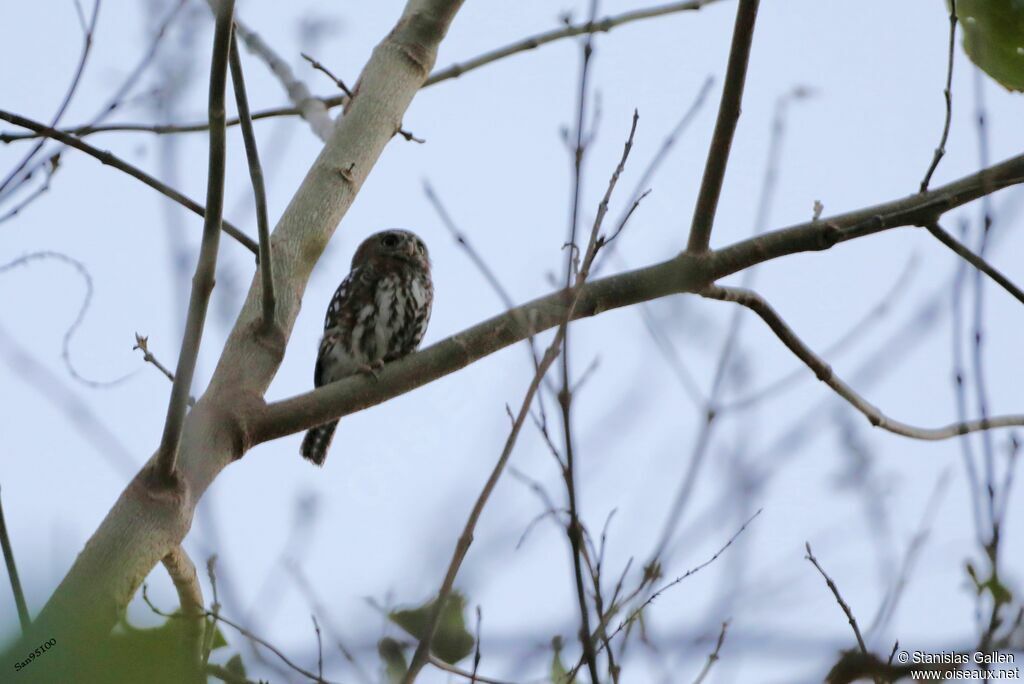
[13,0,462,671]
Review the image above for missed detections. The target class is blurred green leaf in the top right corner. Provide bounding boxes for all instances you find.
[946,0,1024,91]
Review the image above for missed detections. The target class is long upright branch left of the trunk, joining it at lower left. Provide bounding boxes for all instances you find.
[156,0,234,482]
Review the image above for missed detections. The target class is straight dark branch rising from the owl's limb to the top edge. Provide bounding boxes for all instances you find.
[686,0,759,253]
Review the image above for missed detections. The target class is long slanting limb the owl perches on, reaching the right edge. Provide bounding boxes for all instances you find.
[249,150,1024,443]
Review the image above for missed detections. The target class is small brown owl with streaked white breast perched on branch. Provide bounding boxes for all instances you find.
[300,229,434,466]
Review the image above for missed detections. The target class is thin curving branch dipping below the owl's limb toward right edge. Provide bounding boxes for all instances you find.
[699,285,1024,440]
